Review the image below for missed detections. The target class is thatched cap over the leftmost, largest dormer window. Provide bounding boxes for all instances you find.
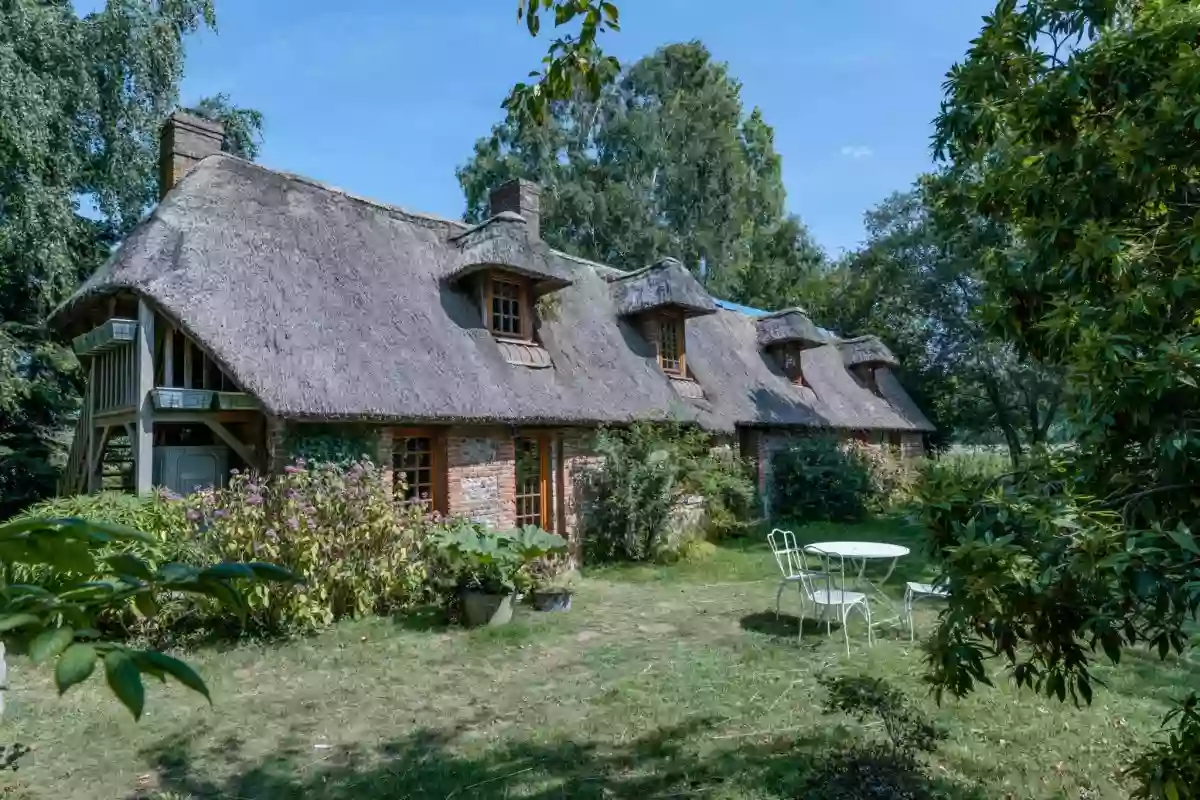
[449,211,571,294]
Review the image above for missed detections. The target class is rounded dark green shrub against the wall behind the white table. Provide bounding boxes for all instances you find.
[770,435,876,522]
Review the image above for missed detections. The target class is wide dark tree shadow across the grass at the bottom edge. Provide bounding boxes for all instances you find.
[131,718,983,800]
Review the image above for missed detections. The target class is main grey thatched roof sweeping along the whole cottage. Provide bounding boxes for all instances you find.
[50,156,929,431]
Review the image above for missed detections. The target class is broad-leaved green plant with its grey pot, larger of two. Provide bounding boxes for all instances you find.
[437,523,566,626]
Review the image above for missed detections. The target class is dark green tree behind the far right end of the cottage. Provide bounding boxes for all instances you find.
[806,175,1062,464]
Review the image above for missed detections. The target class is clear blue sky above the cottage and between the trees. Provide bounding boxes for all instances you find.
[142,0,994,253]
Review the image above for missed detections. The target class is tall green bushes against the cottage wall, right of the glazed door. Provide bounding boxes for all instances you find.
[580,422,754,561]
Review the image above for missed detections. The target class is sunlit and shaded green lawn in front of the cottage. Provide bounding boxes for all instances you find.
[0,523,1200,800]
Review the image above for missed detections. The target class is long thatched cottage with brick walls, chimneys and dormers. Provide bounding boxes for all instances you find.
[50,114,932,533]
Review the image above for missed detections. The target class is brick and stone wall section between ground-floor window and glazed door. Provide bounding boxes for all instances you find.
[445,427,517,529]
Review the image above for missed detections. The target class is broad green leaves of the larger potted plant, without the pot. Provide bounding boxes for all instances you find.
[430,522,566,595]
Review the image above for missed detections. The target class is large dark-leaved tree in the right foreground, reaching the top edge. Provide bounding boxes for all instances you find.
[932,0,1200,798]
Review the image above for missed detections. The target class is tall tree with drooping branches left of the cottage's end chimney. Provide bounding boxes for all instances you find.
[0,0,262,517]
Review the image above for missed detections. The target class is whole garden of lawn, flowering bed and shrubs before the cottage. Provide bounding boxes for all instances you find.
[0,426,1200,800]
